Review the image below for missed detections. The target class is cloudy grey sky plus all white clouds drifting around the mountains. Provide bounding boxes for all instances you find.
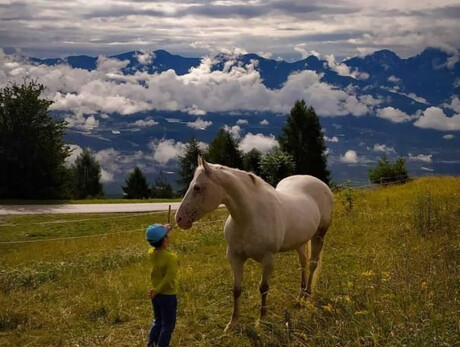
[0,0,460,188]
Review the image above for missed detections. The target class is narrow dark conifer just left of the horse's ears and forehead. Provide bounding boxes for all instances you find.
[177,137,203,196]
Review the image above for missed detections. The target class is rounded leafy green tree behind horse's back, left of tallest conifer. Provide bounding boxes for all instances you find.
[260,147,295,186]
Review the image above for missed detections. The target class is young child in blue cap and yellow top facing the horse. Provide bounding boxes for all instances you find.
[145,224,179,347]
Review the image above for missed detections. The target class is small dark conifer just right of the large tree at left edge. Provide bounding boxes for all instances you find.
[73,149,104,199]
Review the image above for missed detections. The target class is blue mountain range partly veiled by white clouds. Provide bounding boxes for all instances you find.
[29,48,460,192]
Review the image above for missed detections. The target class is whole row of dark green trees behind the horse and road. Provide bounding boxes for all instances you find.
[0,80,407,199]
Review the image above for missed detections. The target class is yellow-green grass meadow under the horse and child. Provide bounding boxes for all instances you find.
[0,178,460,346]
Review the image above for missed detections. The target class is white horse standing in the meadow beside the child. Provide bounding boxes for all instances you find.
[176,157,333,330]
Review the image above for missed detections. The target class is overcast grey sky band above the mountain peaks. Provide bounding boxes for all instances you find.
[0,0,460,61]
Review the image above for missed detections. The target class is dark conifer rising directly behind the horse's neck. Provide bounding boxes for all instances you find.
[206,128,243,169]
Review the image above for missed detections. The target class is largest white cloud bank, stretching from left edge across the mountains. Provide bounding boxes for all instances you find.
[0,51,373,123]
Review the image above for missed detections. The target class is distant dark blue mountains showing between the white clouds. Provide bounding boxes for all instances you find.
[30,48,460,192]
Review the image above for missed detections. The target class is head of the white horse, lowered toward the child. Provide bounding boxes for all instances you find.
[176,156,223,229]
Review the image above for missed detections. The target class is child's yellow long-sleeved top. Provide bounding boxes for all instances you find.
[148,248,179,295]
